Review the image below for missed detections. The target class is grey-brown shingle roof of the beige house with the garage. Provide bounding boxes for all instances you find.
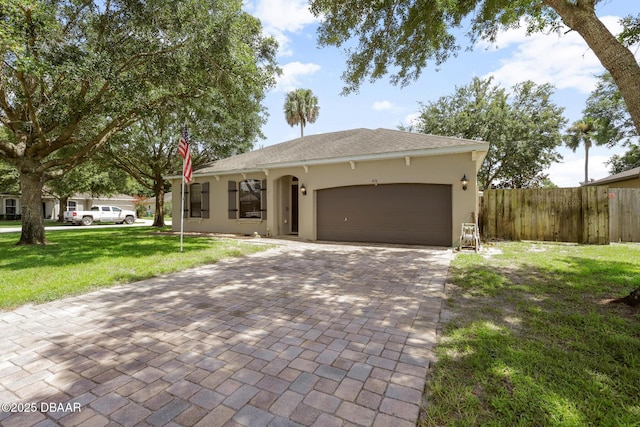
[194,129,488,175]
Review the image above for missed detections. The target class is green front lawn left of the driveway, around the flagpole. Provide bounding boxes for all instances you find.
[0,227,265,309]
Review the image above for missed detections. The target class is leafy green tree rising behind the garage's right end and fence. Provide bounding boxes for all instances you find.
[404,78,566,188]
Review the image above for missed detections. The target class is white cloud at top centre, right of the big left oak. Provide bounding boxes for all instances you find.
[244,0,317,56]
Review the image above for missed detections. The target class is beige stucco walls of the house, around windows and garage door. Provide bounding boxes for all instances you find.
[173,152,485,246]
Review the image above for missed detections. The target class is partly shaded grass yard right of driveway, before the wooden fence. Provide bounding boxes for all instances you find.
[419,242,640,426]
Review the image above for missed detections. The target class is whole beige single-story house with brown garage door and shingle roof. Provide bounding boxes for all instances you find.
[168,129,489,246]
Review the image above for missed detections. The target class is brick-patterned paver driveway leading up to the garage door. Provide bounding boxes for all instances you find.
[0,242,451,427]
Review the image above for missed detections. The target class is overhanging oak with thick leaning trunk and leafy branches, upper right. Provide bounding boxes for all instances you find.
[310,0,640,135]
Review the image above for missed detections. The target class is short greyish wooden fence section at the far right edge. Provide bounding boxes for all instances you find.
[609,188,640,242]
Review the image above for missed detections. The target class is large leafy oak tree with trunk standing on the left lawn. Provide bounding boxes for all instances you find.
[0,0,277,244]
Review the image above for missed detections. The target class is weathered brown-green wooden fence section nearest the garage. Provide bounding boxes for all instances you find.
[480,186,609,245]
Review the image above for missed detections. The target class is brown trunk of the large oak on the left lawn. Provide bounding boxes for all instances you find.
[18,170,47,245]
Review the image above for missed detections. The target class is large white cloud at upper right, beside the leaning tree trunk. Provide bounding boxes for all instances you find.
[477,16,621,94]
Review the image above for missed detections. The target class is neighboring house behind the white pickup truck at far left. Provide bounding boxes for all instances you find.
[0,194,135,219]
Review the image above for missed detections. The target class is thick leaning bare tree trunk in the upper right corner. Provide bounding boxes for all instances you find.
[544,0,640,132]
